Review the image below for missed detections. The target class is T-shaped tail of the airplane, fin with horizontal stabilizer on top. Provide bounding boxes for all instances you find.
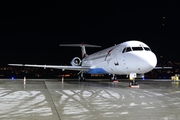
[59,42,101,58]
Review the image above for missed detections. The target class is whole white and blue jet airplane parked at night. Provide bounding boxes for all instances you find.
[8,40,169,85]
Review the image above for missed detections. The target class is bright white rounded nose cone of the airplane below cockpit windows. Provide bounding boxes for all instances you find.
[138,52,157,72]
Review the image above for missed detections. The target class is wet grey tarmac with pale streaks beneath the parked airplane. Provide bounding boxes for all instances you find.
[0,79,180,120]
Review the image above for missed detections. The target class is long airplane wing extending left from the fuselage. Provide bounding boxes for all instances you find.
[8,64,90,71]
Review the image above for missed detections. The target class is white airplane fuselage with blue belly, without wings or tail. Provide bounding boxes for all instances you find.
[82,40,157,74]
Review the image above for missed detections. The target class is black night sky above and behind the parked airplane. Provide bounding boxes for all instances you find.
[0,0,180,64]
